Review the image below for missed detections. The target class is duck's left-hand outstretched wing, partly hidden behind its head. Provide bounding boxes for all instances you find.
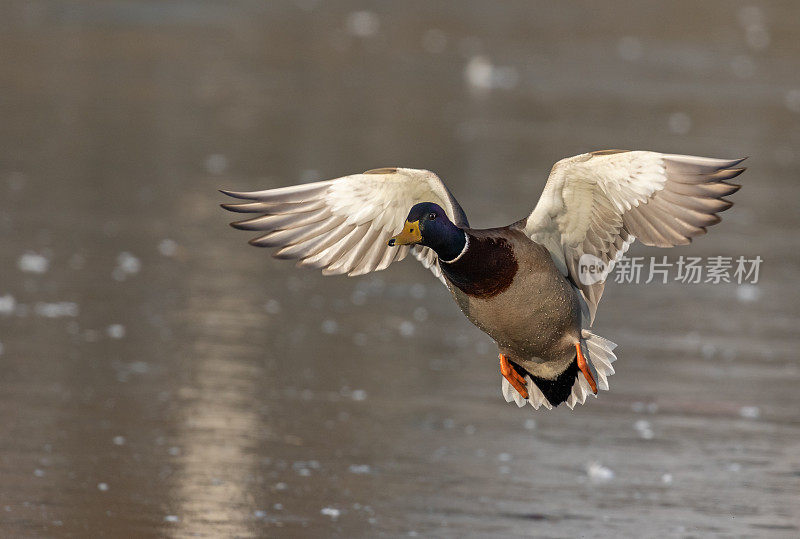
[222,168,468,278]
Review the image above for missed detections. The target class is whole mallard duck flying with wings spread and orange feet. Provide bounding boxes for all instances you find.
[222,150,744,409]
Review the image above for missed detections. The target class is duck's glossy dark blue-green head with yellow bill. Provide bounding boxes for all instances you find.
[389,202,466,260]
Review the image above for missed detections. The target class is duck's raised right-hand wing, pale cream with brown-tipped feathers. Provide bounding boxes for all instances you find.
[517,150,744,321]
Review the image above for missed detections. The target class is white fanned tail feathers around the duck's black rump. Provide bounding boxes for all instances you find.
[502,329,617,410]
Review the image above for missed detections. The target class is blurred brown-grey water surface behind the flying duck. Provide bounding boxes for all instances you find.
[0,0,800,537]
